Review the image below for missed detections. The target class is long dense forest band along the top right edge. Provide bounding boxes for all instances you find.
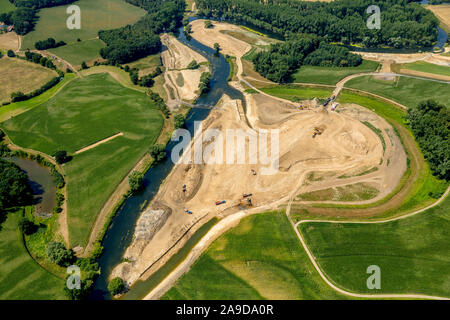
[196,0,438,48]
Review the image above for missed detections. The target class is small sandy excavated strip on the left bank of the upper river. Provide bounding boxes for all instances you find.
[161,34,209,102]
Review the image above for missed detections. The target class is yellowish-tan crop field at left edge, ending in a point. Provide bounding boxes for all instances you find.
[0,57,58,104]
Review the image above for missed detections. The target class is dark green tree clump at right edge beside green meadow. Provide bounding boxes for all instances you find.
[408,100,450,181]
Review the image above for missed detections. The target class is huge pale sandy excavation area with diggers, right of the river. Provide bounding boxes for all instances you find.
[112,88,406,285]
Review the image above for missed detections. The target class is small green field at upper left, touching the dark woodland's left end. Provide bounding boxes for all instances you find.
[49,39,106,66]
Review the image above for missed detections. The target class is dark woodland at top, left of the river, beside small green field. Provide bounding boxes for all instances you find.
[99,0,185,64]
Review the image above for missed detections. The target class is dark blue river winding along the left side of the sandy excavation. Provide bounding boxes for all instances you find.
[91,18,245,300]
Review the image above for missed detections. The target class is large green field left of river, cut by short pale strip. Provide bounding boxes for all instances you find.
[2,73,163,246]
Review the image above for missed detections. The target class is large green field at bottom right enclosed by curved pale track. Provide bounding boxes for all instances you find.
[300,197,450,297]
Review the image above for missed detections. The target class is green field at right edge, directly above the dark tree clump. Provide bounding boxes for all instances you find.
[345,76,450,108]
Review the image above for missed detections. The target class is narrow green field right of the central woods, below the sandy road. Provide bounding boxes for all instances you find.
[292,60,380,84]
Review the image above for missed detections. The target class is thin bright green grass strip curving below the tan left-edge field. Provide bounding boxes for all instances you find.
[0,73,75,122]
